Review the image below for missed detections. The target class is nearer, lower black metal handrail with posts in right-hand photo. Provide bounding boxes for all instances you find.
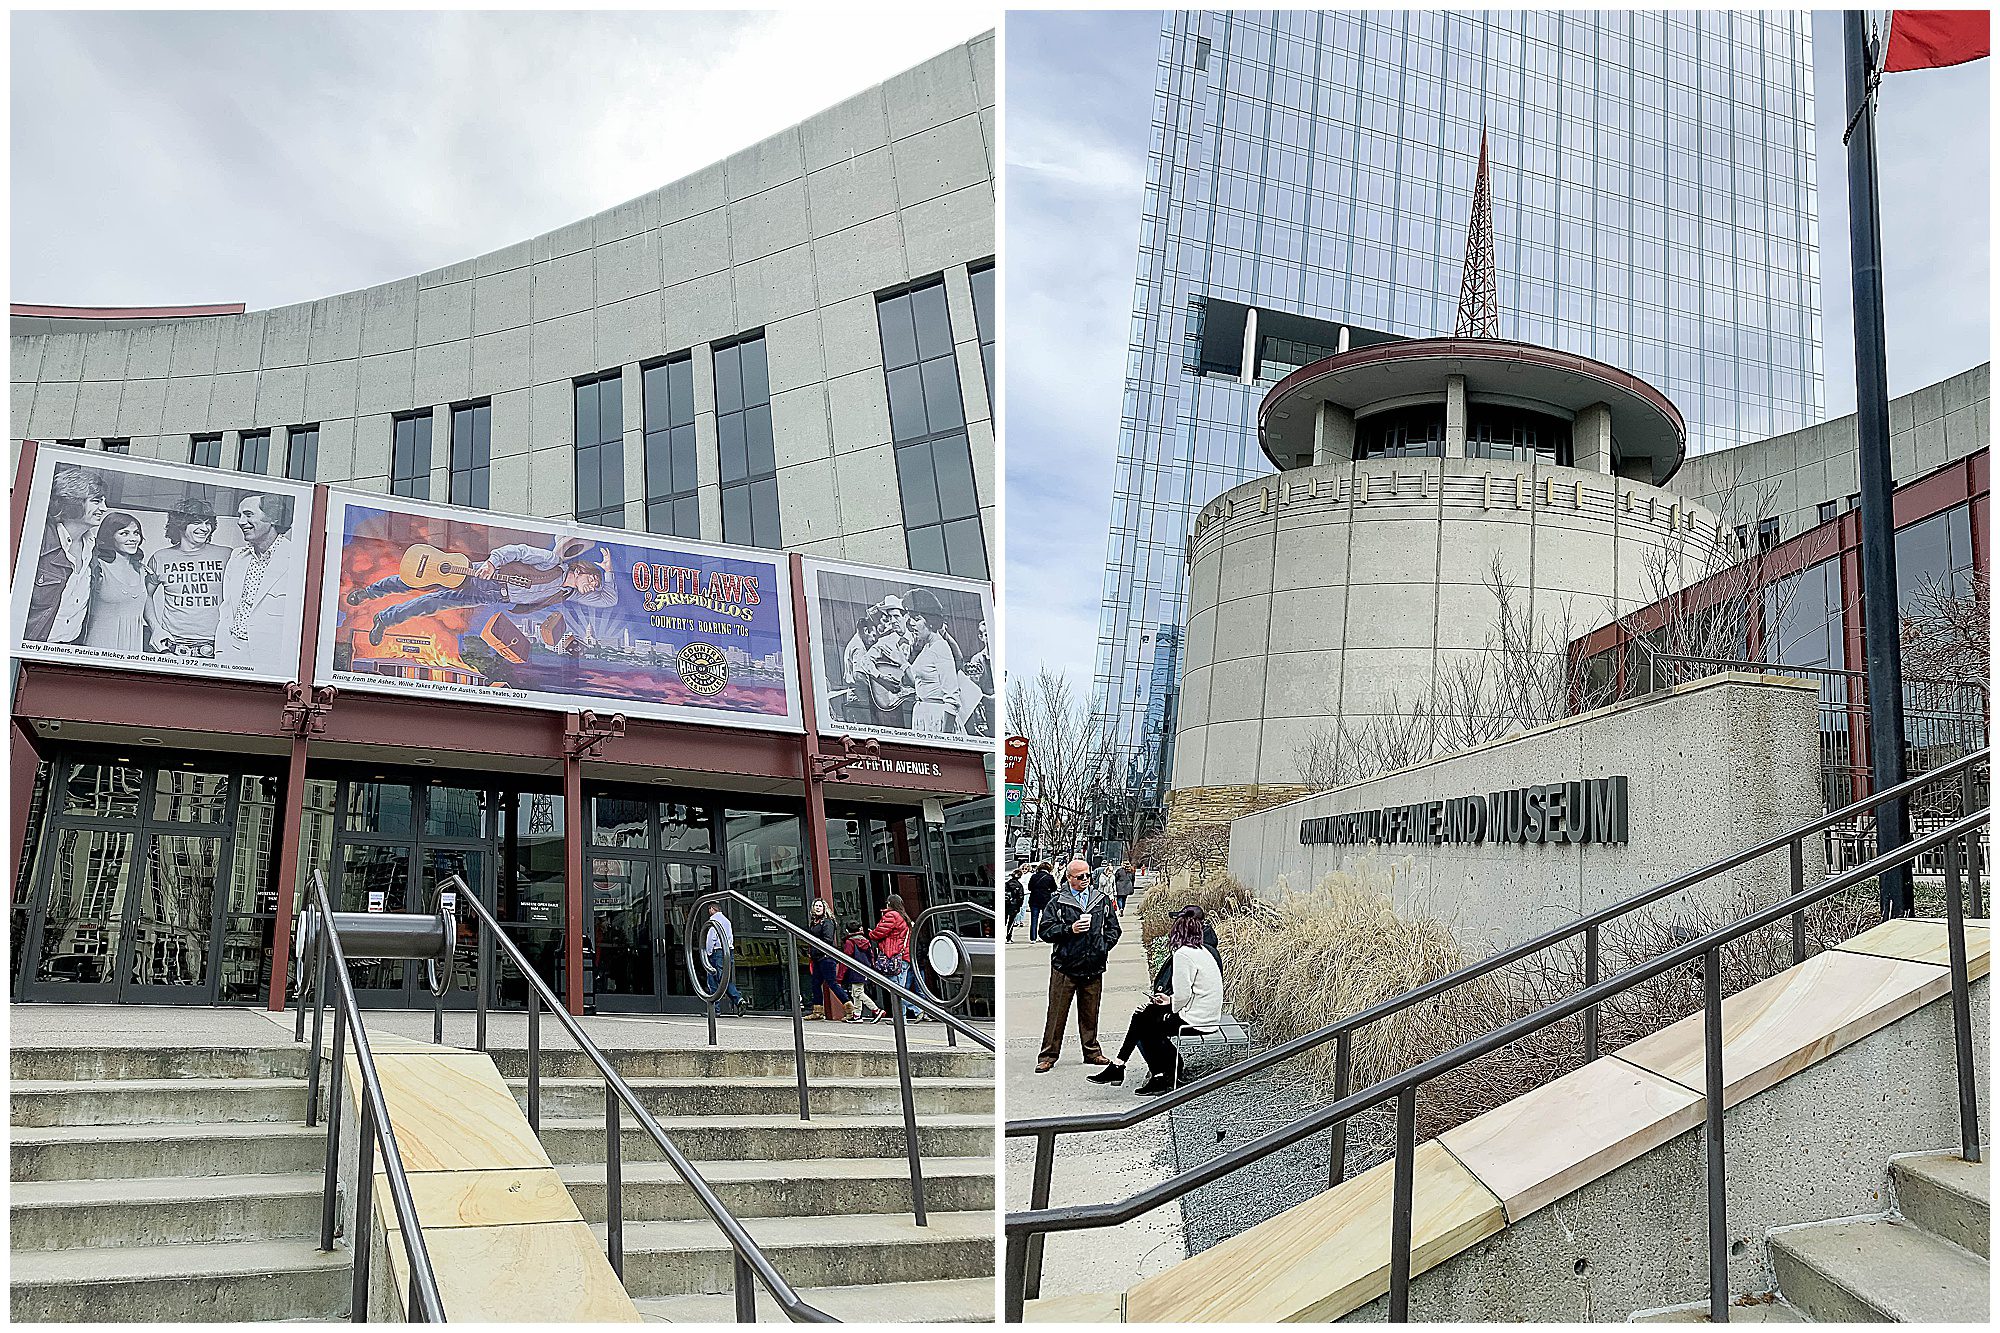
[1006,792,1990,1321]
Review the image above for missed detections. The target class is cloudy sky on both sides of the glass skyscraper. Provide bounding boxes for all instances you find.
[1002,12,1992,689]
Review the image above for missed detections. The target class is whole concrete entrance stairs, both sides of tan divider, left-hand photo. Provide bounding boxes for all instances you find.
[10,1047,994,1323]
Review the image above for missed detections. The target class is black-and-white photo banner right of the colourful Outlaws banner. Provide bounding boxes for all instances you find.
[804,560,996,753]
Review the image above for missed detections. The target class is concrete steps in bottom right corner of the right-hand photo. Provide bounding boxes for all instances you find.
[1770,1153,1992,1323]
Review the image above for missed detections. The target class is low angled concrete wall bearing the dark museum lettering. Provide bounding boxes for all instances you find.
[1230,675,1824,955]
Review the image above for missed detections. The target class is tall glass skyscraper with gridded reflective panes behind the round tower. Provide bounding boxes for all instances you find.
[1094,10,1822,831]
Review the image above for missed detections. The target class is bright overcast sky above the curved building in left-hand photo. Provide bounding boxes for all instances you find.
[8,4,996,310]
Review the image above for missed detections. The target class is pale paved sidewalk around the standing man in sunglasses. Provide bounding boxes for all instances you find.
[1006,897,1188,1297]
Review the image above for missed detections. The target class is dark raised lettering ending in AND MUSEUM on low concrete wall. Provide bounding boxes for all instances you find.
[1298,777,1628,847]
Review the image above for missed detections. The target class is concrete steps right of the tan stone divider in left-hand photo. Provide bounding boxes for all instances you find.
[494,1047,994,1323]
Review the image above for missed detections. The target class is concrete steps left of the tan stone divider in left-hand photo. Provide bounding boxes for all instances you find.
[8,1047,350,1323]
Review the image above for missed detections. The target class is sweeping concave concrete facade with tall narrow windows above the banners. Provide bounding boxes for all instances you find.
[12,36,996,566]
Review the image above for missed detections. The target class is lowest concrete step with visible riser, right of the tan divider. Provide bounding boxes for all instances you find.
[592,1211,994,1305]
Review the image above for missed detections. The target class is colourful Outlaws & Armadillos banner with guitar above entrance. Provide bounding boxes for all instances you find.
[318,492,802,731]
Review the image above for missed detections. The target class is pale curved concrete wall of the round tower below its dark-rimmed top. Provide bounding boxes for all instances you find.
[1174,458,1734,799]
